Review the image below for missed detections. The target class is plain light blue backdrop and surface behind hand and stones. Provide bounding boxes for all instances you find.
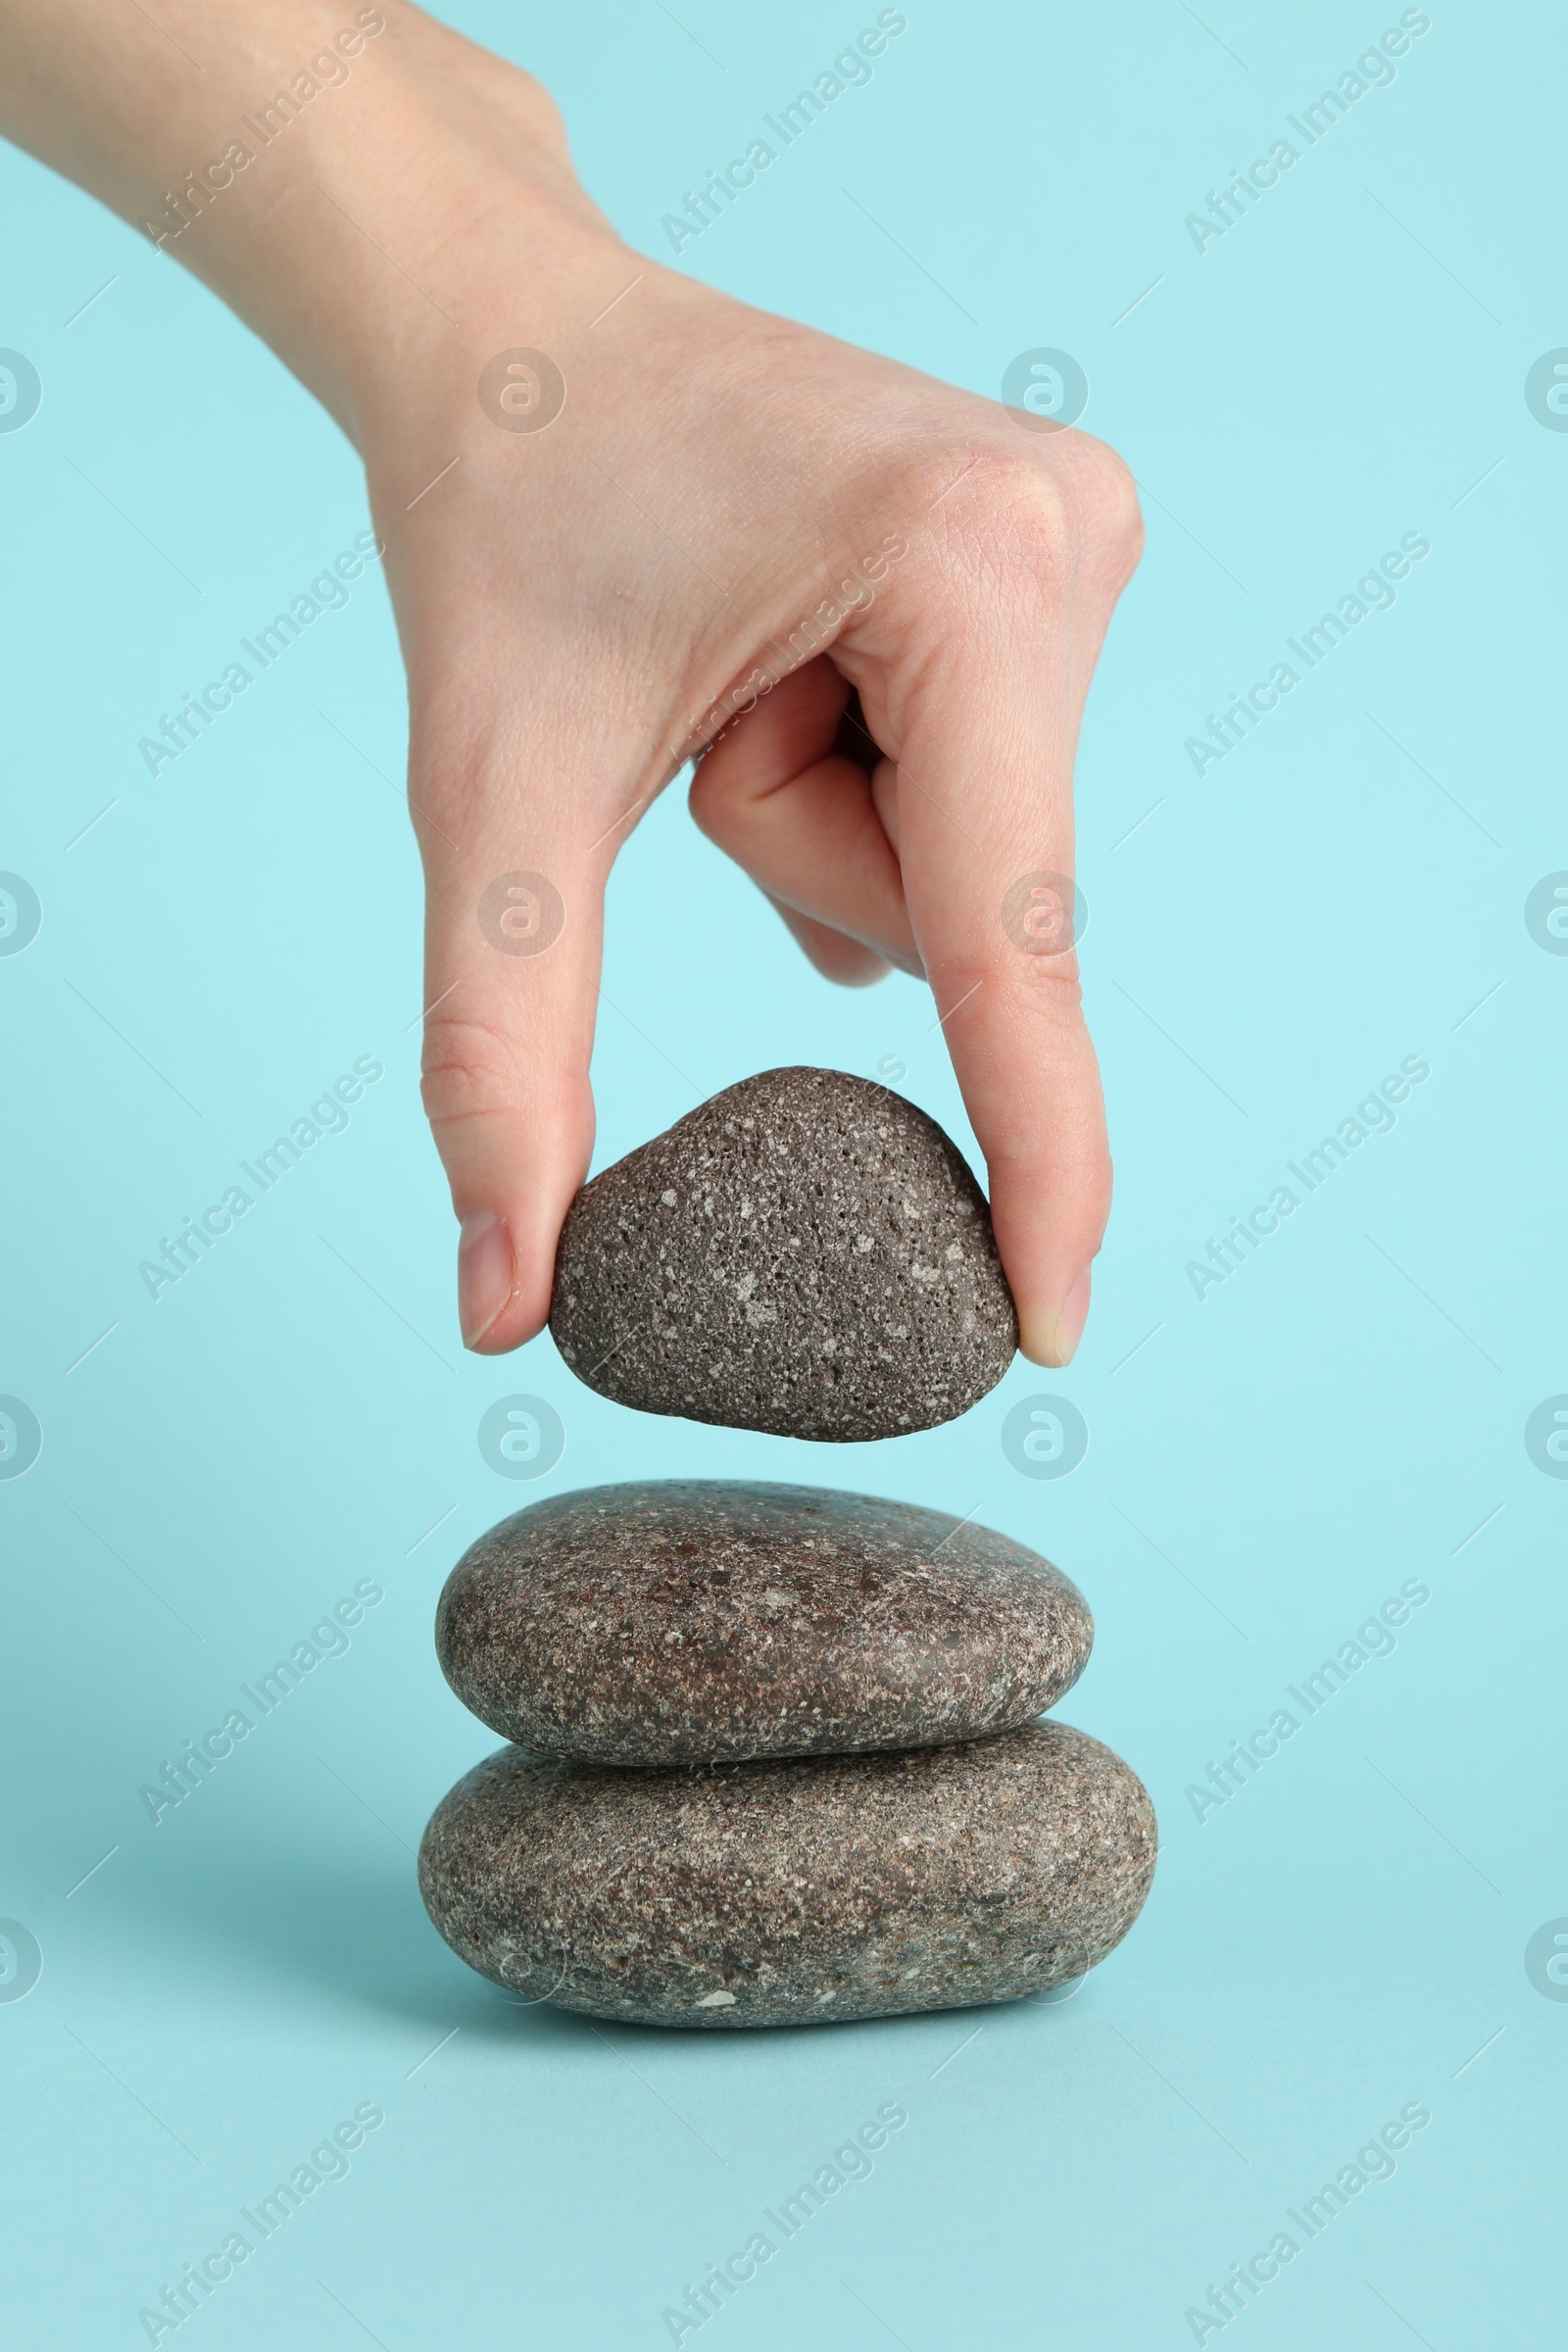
[0,0,1568,2352]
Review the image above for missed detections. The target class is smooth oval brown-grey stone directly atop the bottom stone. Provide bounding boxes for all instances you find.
[435,1480,1093,1764]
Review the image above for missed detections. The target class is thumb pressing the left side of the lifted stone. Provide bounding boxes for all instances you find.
[412,714,609,1354]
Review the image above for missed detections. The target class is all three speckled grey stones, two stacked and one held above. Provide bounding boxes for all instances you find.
[418,1070,1154,2025]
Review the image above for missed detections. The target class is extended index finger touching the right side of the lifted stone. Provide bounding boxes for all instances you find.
[869,435,1138,1364]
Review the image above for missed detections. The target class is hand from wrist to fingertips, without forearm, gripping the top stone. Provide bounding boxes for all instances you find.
[352,55,1140,1364]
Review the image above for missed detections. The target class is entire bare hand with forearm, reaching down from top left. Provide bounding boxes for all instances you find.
[0,0,1140,1364]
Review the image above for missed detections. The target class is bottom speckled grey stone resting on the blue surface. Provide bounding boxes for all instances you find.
[418,1722,1156,2025]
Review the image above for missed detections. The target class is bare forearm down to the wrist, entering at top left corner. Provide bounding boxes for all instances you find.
[0,0,613,447]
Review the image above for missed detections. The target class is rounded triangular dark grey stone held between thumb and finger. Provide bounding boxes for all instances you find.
[550,1070,1018,1440]
